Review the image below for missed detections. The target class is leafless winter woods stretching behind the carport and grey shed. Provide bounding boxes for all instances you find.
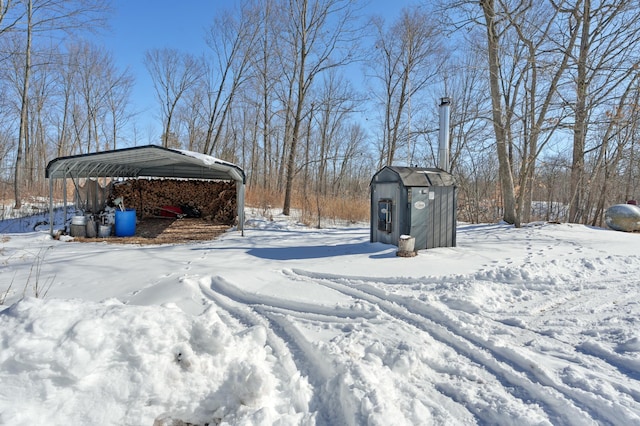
[0,0,640,226]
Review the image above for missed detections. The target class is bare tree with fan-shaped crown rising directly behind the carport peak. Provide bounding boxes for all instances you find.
[144,48,203,147]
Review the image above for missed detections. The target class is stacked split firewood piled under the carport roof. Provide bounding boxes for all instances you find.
[110,179,238,225]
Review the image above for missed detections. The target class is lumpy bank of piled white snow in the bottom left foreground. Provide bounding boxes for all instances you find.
[0,298,308,425]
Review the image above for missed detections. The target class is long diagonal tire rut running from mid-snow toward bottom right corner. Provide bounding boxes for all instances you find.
[291,269,622,424]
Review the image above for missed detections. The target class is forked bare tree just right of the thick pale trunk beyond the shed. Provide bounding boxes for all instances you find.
[504,4,578,222]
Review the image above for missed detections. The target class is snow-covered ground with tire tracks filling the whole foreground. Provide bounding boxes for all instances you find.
[0,211,640,426]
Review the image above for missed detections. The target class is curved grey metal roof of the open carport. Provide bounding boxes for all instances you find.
[46,145,245,183]
